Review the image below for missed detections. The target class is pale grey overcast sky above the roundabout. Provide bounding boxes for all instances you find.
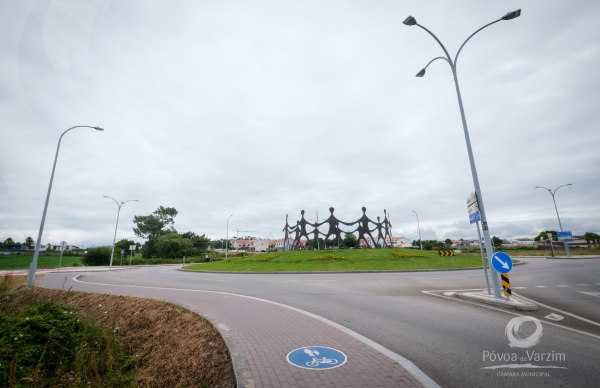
[0,0,600,247]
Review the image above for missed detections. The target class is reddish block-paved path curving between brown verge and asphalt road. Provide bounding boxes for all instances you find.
[36,273,438,388]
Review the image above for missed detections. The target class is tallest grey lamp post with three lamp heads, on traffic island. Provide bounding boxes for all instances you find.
[403,9,521,298]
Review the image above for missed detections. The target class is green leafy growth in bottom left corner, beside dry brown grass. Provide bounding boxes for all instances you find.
[0,277,135,387]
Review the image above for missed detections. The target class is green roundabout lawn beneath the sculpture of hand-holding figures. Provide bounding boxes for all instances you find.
[185,249,492,272]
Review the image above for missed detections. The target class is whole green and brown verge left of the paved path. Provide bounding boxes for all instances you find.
[0,276,235,387]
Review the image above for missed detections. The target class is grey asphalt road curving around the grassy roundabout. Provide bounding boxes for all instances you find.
[54,258,600,387]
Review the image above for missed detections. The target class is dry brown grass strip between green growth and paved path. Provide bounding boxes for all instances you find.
[4,276,235,387]
